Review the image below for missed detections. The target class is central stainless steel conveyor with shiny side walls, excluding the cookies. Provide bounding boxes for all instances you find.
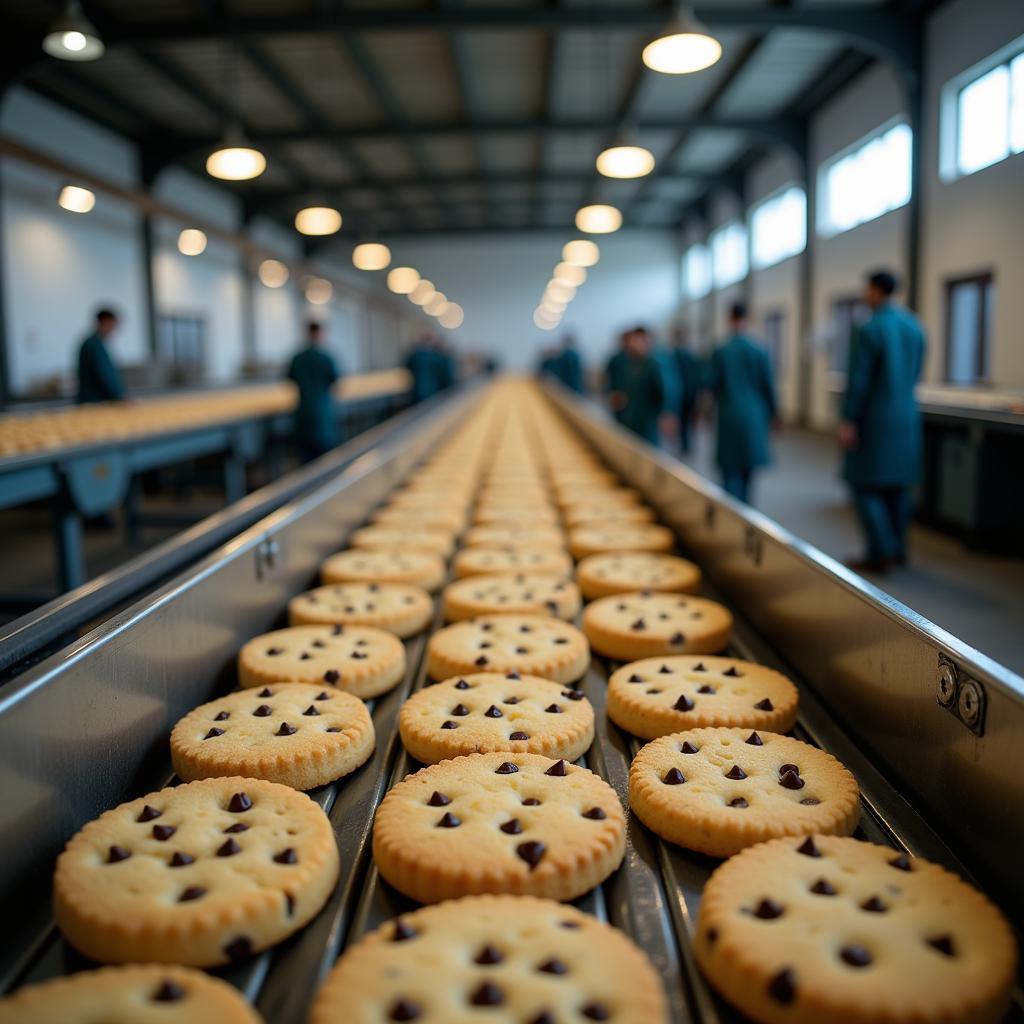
[0,389,1024,1024]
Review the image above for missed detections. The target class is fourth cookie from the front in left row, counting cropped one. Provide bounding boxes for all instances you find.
[239,626,406,699]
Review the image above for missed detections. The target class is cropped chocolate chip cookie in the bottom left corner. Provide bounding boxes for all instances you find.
[0,964,261,1024]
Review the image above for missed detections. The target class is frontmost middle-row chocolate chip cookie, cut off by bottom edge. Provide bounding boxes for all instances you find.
[310,896,669,1024]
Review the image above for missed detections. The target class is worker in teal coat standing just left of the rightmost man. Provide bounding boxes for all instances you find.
[708,302,776,502]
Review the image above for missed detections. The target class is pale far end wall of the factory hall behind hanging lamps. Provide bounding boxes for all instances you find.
[393,230,680,370]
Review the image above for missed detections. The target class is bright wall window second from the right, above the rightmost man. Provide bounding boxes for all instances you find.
[818,122,911,237]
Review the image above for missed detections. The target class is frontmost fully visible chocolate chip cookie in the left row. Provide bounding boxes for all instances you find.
[53,778,338,967]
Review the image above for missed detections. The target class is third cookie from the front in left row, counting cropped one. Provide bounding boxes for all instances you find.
[171,683,374,790]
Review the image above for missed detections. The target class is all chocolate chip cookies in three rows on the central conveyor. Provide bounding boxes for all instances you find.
[0,381,1016,1024]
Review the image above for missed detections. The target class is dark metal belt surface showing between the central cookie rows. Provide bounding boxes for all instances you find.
[0,380,1024,1024]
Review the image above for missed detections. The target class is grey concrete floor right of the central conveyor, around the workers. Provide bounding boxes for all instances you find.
[686,429,1024,675]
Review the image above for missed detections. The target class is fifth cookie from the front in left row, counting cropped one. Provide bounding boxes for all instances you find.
[288,583,434,637]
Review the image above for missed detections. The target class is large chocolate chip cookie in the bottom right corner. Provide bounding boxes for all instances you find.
[694,836,1017,1024]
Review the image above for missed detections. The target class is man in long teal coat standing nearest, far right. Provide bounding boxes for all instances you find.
[840,270,925,572]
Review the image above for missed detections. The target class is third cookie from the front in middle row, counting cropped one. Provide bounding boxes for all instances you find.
[398,672,594,764]
